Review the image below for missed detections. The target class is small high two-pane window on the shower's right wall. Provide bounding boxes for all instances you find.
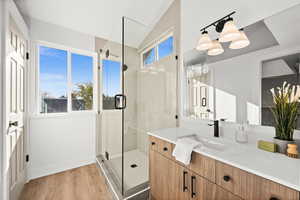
[142,36,174,66]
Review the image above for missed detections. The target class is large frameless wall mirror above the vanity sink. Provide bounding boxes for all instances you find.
[183,4,300,127]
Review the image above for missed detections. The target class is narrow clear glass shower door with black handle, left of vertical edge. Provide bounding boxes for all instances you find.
[97,55,123,195]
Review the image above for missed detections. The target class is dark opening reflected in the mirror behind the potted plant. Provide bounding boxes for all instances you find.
[261,53,300,128]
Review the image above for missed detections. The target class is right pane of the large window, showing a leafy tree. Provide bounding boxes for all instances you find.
[71,54,93,111]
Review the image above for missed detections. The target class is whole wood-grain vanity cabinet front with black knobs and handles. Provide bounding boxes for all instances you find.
[149,136,300,200]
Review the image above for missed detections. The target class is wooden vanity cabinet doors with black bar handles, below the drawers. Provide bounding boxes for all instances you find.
[149,150,240,200]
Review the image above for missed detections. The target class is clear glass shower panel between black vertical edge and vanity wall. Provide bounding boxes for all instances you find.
[119,17,177,196]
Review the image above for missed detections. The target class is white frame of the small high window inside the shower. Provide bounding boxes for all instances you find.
[140,31,176,69]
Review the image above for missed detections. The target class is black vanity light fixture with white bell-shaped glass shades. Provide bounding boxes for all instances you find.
[196,12,250,56]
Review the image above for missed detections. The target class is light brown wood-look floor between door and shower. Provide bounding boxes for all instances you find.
[20,164,113,200]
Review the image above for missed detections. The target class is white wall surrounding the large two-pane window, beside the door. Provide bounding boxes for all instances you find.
[29,19,96,179]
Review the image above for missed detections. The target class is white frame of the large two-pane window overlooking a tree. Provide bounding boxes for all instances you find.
[35,41,99,116]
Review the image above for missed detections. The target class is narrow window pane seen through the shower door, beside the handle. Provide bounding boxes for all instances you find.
[102,60,122,110]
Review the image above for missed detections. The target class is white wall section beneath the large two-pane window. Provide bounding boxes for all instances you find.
[28,114,96,179]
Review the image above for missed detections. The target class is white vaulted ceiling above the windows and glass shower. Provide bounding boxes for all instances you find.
[15,0,173,47]
